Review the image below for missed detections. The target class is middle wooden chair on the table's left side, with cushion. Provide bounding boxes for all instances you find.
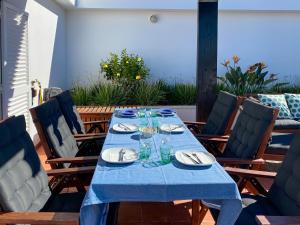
[30,99,103,172]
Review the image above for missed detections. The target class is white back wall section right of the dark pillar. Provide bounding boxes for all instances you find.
[218,11,300,84]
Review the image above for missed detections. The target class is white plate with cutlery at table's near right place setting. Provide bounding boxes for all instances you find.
[175,150,216,166]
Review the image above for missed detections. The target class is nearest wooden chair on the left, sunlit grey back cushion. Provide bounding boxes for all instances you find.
[0,116,118,225]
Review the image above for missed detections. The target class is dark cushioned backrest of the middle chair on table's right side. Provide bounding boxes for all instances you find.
[223,99,278,159]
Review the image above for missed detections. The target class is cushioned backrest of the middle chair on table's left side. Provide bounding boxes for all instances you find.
[30,99,79,168]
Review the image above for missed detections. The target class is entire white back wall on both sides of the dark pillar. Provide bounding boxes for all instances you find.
[67,7,300,87]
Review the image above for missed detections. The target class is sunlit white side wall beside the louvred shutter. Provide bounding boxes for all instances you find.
[7,0,66,87]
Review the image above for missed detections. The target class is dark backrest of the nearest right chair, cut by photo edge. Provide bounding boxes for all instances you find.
[267,132,300,216]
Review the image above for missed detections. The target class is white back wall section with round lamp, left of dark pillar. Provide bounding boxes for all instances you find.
[67,10,197,85]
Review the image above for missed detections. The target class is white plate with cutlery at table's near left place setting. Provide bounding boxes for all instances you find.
[101,147,138,164]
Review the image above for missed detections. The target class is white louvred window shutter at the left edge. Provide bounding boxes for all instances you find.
[1,1,30,128]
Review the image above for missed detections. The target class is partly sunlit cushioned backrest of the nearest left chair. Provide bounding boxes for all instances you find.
[0,116,51,211]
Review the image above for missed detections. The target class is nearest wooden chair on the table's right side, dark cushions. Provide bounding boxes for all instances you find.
[203,133,300,225]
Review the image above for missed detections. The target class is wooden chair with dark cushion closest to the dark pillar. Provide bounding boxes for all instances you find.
[185,91,243,136]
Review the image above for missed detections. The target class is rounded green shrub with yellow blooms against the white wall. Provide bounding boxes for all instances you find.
[100,49,149,84]
